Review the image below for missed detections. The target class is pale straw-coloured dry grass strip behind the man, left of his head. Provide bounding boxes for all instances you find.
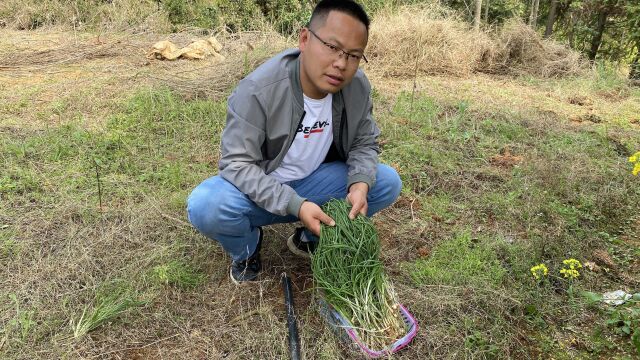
[0,29,290,131]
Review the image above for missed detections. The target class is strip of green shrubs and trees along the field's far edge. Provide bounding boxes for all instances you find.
[0,0,640,79]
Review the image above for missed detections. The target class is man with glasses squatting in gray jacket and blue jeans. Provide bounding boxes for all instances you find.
[187,0,402,284]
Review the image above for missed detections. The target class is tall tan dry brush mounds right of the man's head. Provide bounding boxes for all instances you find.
[366,5,587,77]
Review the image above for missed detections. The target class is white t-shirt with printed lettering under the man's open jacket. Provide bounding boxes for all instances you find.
[269,94,333,183]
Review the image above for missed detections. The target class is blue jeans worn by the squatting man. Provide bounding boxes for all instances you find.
[187,161,402,261]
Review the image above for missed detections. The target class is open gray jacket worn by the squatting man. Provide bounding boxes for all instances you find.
[219,49,380,216]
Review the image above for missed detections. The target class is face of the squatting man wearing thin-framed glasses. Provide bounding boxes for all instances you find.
[299,11,367,99]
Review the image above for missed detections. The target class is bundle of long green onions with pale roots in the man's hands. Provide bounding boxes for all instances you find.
[311,200,405,349]
